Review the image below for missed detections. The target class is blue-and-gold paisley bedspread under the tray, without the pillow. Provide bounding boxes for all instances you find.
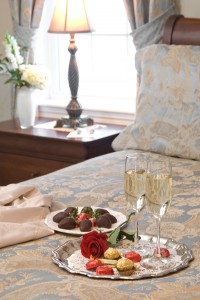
[0,150,200,300]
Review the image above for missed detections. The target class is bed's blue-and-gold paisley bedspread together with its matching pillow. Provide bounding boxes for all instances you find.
[0,14,200,300]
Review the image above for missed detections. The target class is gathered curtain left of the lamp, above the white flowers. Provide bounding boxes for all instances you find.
[9,0,45,63]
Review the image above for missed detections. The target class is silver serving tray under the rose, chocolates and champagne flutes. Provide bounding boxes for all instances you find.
[52,235,193,280]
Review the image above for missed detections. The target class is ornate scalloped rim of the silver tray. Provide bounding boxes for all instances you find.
[52,235,194,280]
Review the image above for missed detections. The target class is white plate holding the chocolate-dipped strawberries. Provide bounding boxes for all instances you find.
[45,206,126,235]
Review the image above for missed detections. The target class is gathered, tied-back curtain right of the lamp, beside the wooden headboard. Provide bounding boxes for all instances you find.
[124,0,177,50]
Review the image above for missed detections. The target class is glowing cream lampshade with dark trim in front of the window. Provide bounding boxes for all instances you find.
[48,0,92,33]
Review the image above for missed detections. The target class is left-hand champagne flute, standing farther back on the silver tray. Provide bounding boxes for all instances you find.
[124,154,147,256]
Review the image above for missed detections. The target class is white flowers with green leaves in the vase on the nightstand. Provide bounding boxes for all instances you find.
[0,33,47,89]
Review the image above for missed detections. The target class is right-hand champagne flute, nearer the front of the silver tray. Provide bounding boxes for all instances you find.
[143,160,172,270]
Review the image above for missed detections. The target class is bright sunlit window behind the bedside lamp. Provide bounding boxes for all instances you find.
[38,0,136,119]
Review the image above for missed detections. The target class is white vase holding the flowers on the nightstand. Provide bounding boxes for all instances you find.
[16,87,37,129]
